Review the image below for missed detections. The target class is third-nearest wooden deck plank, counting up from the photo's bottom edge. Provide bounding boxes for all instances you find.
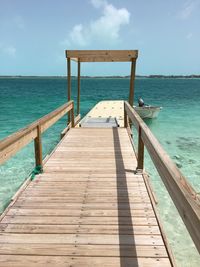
[0,233,164,246]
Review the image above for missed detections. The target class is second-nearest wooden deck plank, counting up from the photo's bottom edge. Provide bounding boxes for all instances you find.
[0,243,167,258]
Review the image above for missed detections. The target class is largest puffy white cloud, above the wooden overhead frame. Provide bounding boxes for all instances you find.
[62,0,130,46]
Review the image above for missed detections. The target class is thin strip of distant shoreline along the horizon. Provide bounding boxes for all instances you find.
[0,74,200,79]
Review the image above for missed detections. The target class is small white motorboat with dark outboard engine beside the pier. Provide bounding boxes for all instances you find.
[134,98,162,119]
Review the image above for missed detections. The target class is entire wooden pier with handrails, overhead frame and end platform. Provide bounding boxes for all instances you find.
[0,51,200,267]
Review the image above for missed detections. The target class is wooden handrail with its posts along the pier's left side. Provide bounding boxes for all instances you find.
[0,101,74,166]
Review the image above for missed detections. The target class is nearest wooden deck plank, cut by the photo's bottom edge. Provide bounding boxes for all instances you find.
[0,255,171,267]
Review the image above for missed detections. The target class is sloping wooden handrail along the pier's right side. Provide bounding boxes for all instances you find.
[124,101,200,252]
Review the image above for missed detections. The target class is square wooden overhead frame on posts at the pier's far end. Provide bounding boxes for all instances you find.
[65,50,138,118]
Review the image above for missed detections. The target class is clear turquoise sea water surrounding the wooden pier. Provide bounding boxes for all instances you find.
[0,77,200,267]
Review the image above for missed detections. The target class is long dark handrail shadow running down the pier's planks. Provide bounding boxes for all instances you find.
[113,128,139,267]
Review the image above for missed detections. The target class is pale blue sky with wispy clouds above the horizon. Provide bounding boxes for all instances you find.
[0,0,200,75]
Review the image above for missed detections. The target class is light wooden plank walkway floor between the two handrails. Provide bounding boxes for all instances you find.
[0,128,171,267]
